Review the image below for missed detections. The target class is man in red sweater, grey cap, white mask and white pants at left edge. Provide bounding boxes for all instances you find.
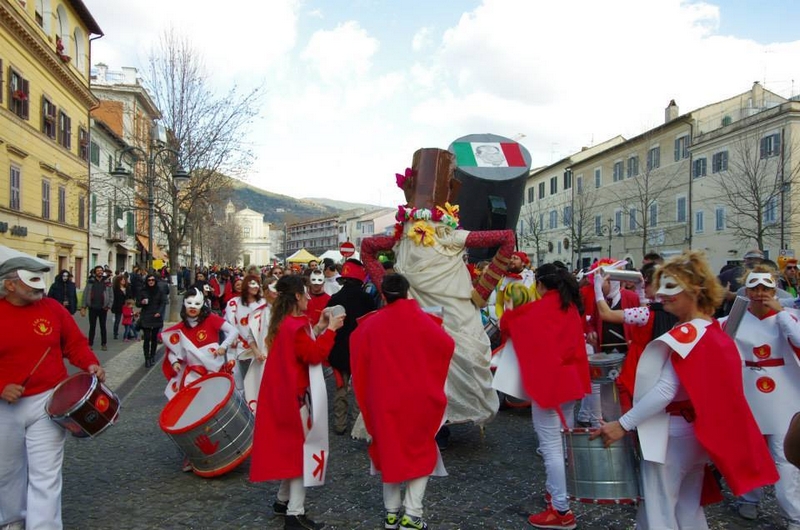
[0,256,105,529]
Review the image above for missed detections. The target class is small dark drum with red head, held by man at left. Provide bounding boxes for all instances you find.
[45,372,120,438]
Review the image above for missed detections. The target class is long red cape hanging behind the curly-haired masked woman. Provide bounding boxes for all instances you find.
[670,320,778,496]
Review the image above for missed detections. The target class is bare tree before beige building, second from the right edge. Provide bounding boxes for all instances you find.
[617,142,688,256]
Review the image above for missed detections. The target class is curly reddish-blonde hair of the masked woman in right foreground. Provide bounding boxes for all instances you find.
[653,250,725,315]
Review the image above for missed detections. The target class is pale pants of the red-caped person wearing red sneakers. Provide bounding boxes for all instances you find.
[531,401,575,512]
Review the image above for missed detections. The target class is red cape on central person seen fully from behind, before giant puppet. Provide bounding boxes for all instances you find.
[350,300,455,483]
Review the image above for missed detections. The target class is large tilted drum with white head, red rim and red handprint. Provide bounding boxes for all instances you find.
[158,372,254,477]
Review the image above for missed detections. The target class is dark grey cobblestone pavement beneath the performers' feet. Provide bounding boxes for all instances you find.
[63,319,784,530]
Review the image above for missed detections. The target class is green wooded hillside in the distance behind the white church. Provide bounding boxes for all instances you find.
[225,179,341,225]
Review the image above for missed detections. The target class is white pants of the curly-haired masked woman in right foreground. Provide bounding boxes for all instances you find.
[636,416,708,530]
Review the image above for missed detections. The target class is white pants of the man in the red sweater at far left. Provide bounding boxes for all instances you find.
[0,391,66,530]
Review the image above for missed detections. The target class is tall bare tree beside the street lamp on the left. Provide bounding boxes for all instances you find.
[139,30,261,272]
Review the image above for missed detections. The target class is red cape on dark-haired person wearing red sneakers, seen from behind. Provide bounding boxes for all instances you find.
[501,291,591,409]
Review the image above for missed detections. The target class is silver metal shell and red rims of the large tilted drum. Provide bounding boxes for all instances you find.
[159,373,255,477]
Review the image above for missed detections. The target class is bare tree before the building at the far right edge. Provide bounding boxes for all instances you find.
[712,130,800,248]
